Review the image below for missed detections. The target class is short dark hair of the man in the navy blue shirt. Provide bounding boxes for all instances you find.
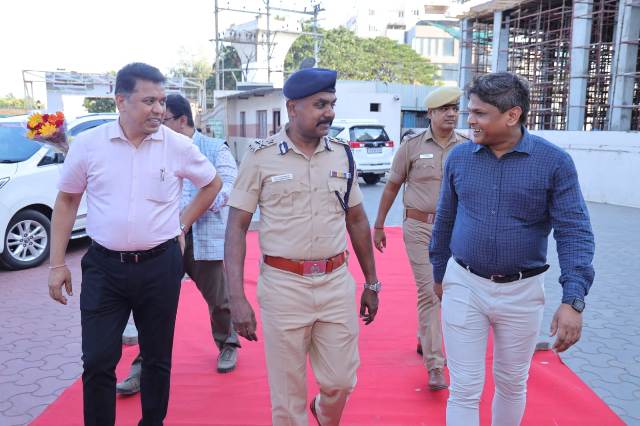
[467,72,529,124]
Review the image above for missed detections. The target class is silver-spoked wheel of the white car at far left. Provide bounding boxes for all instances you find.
[0,210,51,269]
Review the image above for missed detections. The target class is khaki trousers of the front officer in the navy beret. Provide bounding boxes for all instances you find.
[257,264,360,426]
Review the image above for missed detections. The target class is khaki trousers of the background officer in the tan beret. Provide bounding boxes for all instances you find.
[402,218,444,371]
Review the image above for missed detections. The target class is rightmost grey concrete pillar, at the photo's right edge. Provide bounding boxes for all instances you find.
[609,0,640,131]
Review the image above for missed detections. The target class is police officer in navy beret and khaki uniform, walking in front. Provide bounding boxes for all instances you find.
[225,68,380,426]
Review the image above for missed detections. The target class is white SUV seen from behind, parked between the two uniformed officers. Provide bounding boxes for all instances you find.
[329,119,394,185]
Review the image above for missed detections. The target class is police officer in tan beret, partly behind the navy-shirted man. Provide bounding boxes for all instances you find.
[374,87,468,390]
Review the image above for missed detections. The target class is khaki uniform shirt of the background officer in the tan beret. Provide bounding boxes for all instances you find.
[389,128,469,213]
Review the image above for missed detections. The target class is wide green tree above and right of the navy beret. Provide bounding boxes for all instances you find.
[284,27,439,85]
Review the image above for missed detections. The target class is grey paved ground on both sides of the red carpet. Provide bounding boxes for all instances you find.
[0,184,640,426]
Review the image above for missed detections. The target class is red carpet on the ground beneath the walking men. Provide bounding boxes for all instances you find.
[33,229,623,426]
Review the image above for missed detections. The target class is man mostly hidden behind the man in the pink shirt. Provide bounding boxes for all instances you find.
[116,94,240,395]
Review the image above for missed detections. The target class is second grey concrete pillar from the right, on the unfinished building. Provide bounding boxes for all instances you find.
[567,0,593,130]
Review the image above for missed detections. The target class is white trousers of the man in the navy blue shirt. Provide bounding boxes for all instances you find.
[442,259,544,426]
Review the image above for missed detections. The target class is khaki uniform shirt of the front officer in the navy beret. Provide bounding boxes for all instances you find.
[228,127,362,260]
